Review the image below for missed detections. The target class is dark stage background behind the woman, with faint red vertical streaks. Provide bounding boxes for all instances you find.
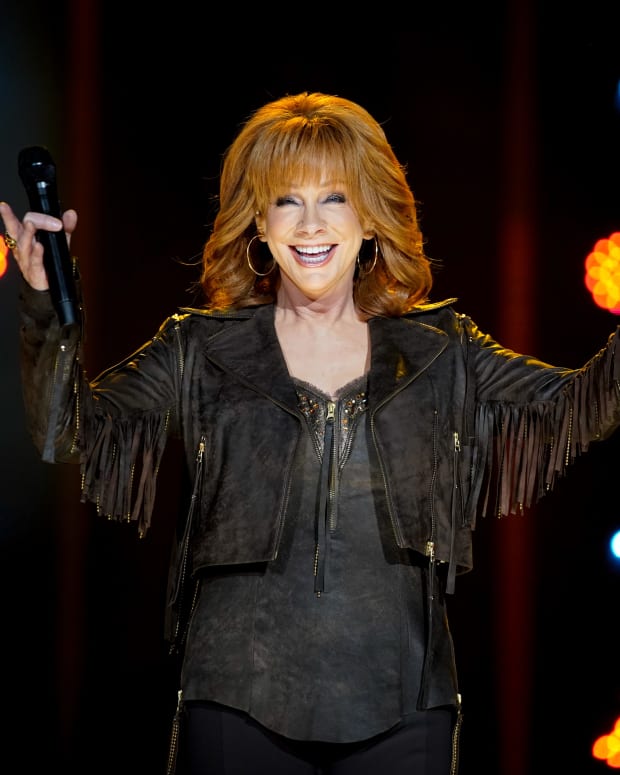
[0,0,620,775]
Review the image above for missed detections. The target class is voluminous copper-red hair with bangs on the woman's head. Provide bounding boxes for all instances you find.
[200,92,432,317]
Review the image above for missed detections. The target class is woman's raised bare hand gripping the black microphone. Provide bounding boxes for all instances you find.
[0,202,77,291]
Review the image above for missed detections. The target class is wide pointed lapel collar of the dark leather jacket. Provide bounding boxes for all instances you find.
[207,304,448,411]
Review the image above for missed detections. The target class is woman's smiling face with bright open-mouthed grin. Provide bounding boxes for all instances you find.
[256,180,372,301]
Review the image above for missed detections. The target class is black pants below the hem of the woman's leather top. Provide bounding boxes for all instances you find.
[180,702,457,775]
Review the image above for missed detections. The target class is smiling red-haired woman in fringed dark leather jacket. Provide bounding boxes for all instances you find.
[0,93,620,775]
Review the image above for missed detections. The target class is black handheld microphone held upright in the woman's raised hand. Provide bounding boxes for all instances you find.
[17,145,80,328]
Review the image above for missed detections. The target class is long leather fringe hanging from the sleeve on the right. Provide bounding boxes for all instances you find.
[473,333,620,516]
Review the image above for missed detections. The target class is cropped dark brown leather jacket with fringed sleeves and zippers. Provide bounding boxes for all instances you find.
[21,280,620,592]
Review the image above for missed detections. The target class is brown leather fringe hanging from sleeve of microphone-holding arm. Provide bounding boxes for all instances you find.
[80,414,169,536]
